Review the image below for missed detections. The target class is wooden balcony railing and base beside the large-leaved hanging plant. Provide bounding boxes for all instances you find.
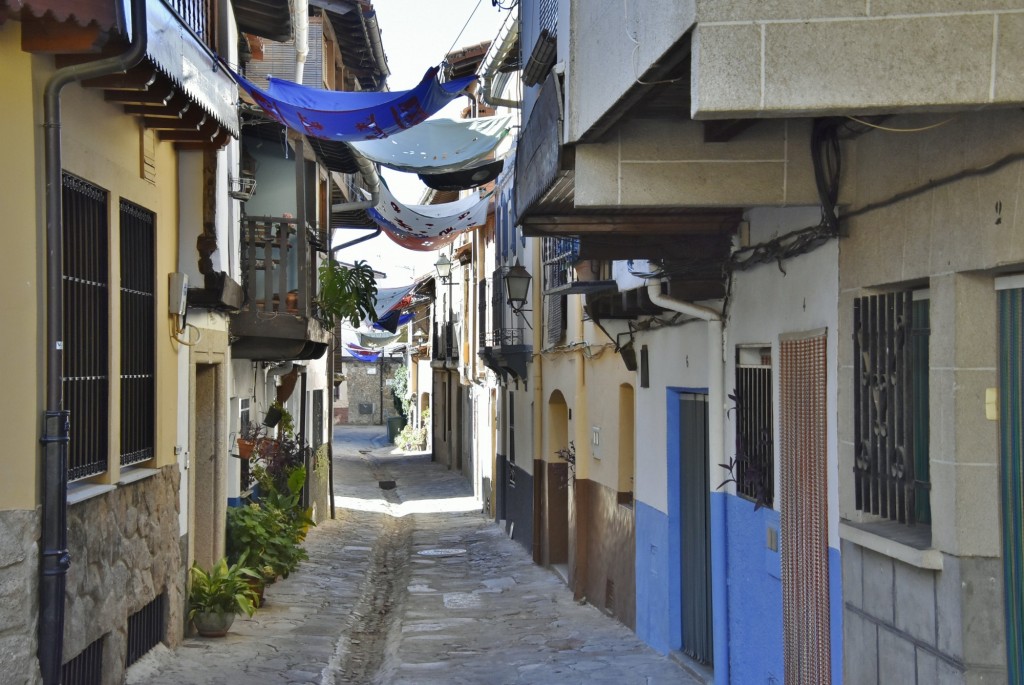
[231,216,331,361]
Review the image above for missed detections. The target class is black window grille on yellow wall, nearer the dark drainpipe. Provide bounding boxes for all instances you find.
[61,174,110,480]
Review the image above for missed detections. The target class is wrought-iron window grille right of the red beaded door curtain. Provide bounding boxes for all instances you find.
[853,291,931,524]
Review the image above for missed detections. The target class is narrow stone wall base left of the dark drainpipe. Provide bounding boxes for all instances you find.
[0,509,41,683]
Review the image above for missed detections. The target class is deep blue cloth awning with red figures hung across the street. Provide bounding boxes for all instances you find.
[234,67,477,142]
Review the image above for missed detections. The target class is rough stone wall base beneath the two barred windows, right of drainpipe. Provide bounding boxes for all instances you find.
[63,466,185,684]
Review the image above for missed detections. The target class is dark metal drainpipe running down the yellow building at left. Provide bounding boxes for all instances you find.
[37,0,146,685]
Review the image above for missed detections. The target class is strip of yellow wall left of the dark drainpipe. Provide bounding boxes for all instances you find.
[0,22,44,509]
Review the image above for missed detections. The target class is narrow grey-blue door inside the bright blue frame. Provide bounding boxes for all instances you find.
[679,392,713,665]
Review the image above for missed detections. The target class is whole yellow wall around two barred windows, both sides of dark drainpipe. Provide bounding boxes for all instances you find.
[0,22,187,510]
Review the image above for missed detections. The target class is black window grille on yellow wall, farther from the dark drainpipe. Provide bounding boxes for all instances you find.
[121,200,156,466]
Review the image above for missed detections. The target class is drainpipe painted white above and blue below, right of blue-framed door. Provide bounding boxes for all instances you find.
[647,280,729,683]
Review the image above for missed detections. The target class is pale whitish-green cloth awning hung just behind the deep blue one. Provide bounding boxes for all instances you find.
[352,115,512,174]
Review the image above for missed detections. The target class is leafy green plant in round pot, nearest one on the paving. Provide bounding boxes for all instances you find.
[188,554,259,637]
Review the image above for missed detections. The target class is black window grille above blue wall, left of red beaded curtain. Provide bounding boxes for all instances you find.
[735,350,775,507]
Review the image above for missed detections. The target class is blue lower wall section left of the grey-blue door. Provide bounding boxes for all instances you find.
[635,500,679,654]
